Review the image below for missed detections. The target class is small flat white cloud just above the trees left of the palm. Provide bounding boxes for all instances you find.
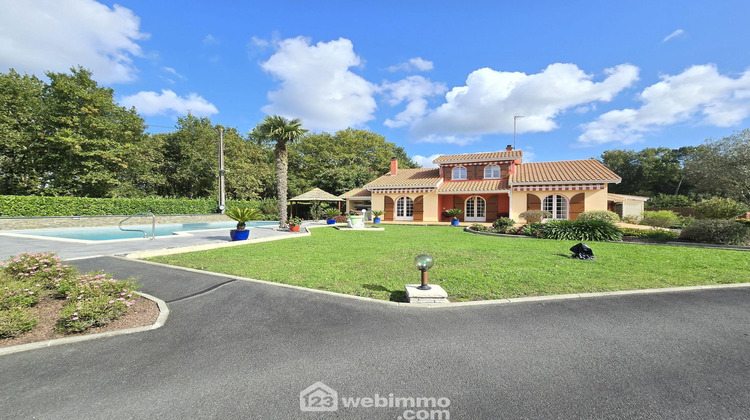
[120,90,219,117]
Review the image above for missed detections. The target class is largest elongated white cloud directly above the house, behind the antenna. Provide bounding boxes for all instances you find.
[412,63,638,144]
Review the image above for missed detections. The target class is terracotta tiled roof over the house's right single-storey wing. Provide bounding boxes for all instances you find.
[510,159,622,185]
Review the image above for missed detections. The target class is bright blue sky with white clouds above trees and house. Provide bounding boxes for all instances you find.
[0,0,750,166]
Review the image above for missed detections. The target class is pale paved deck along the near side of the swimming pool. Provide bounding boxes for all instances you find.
[0,222,312,261]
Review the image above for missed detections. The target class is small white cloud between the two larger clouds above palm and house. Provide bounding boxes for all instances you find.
[381,76,448,128]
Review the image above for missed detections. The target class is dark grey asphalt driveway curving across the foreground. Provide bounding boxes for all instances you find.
[0,257,750,419]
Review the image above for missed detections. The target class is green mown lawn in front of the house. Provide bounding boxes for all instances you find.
[149,225,750,301]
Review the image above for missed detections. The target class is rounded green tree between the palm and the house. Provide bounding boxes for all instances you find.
[289,128,417,195]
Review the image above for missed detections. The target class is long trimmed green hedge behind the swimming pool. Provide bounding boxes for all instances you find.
[0,195,270,217]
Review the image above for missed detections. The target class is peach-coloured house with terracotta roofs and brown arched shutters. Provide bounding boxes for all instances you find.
[341,146,622,222]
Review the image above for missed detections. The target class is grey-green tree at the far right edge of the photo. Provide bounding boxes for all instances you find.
[685,129,750,204]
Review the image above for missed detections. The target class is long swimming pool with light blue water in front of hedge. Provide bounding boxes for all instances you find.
[0,221,279,241]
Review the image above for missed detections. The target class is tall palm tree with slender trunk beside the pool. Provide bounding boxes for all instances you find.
[257,115,307,228]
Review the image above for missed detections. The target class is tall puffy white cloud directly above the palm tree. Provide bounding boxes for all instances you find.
[261,37,378,131]
